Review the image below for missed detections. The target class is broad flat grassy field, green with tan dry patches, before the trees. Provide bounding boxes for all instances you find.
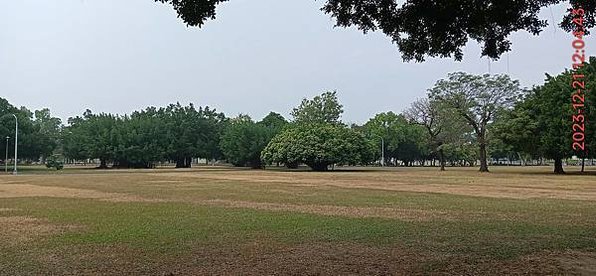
[0,167,596,275]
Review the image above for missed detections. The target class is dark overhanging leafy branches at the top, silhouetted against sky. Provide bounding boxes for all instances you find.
[154,0,596,62]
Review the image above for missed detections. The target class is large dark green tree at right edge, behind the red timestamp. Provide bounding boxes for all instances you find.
[496,57,596,174]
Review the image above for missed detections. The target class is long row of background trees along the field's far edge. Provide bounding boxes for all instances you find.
[0,58,596,173]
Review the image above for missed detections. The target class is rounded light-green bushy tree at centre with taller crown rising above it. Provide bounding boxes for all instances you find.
[261,91,374,171]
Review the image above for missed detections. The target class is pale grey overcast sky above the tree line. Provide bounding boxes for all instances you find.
[0,0,596,123]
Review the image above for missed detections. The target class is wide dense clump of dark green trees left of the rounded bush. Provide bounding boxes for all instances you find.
[62,103,227,168]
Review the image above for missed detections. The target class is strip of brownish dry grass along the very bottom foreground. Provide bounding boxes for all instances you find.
[19,240,596,276]
